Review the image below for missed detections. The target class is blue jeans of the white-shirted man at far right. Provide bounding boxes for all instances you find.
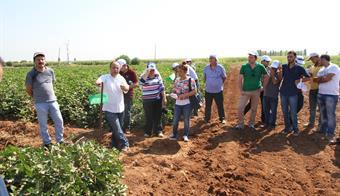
[318,94,339,137]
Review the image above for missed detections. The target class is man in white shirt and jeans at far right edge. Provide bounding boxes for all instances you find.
[313,55,340,144]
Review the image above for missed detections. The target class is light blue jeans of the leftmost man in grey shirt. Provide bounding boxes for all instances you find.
[35,101,64,145]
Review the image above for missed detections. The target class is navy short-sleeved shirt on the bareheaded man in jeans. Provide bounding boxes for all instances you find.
[280,64,309,96]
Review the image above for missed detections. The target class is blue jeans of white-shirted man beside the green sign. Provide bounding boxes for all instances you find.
[105,111,129,149]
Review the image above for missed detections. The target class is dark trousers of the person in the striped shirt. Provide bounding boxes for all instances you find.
[143,99,162,135]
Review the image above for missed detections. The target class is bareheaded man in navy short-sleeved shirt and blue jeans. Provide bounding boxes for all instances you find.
[278,51,309,136]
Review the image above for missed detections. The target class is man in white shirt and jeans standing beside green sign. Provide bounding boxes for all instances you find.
[96,61,129,152]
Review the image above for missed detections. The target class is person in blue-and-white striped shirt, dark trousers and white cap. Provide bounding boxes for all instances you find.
[139,63,166,137]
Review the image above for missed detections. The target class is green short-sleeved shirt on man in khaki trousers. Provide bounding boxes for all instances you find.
[240,62,268,91]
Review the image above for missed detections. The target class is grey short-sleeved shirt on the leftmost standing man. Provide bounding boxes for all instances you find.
[25,67,57,103]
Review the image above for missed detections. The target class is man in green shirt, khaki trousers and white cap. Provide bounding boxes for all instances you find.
[236,52,268,129]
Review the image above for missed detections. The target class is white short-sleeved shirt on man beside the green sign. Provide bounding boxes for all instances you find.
[97,74,127,113]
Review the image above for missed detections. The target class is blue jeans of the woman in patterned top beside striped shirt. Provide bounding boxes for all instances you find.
[173,104,191,137]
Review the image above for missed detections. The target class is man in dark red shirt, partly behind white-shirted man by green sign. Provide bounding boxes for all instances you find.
[117,59,138,133]
